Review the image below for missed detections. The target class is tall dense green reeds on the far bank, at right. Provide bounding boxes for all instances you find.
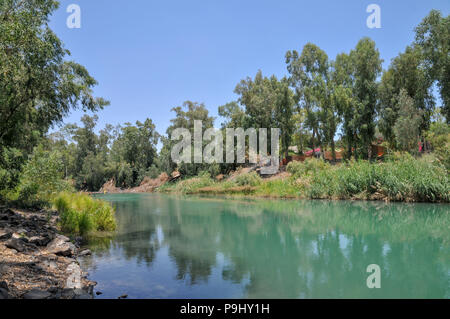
[287,154,450,202]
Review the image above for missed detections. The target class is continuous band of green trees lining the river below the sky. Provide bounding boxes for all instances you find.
[0,0,450,197]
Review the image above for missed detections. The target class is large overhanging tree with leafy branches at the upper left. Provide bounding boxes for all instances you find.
[0,0,108,152]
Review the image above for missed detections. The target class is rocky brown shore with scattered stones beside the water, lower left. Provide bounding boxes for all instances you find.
[0,207,96,299]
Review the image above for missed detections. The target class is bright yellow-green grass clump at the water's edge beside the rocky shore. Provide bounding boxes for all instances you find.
[53,192,116,234]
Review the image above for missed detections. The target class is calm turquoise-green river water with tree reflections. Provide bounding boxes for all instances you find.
[84,194,450,298]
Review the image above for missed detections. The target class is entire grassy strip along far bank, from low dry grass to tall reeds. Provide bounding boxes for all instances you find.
[159,155,450,203]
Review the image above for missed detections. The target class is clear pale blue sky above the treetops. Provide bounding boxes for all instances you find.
[51,0,450,133]
